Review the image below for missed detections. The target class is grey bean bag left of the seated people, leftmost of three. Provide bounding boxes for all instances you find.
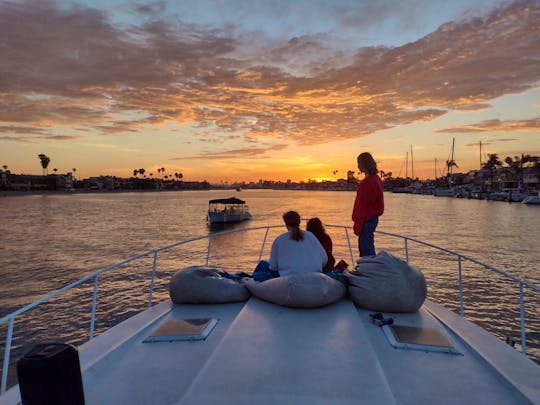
[169,266,250,304]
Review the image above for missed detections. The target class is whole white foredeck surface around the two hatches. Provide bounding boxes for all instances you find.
[4,297,540,405]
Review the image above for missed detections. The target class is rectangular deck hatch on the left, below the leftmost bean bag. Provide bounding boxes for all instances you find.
[143,318,217,343]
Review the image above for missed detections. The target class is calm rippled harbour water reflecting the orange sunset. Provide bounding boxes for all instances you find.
[0,190,540,386]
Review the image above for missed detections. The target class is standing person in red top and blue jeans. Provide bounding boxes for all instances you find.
[352,152,384,256]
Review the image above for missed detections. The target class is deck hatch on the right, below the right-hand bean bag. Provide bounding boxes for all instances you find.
[382,325,461,354]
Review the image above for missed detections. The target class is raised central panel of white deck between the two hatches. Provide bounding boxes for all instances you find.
[178,298,395,404]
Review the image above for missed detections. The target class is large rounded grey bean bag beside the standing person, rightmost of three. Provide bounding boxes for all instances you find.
[344,251,427,312]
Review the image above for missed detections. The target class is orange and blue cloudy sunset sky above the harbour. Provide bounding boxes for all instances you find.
[0,0,540,183]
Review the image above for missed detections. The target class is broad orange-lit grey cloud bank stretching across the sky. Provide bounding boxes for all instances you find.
[0,0,540,145]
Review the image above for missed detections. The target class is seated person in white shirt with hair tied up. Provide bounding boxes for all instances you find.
[253,211,328,281]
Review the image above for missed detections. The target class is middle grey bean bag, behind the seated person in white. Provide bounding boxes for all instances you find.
[244,272,347,308]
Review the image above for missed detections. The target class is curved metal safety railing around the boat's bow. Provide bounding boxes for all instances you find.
[0,225,540,394]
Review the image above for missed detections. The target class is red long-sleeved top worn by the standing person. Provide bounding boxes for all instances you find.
[352,174,384,235]
